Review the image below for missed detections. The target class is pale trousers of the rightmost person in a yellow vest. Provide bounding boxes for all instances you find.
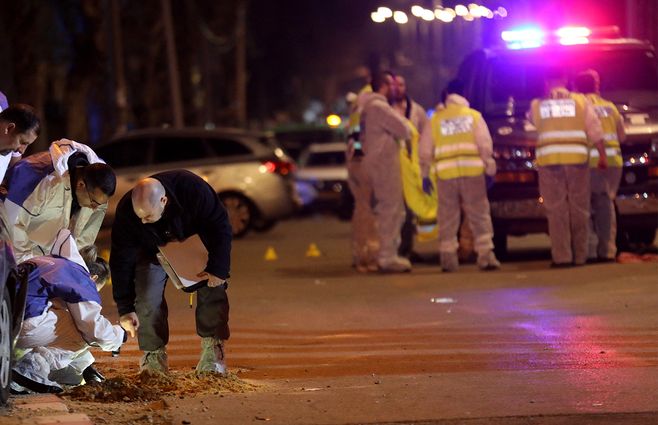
[589,167,622,258]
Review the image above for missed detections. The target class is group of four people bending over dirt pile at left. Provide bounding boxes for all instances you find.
[0,96,232,393]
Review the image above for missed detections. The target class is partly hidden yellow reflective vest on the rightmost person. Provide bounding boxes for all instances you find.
[587,93,624,168]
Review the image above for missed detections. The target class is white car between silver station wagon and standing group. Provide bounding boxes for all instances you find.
[295,142,353,218]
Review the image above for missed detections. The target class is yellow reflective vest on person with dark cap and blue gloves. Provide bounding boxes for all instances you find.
[431,104,484,180]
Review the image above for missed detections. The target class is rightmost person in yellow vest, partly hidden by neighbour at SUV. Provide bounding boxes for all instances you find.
[575,69,626,262]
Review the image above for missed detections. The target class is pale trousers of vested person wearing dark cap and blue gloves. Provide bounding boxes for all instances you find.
[436,176,494,255]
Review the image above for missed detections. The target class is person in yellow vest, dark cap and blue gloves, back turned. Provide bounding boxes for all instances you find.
[419,80,500,272]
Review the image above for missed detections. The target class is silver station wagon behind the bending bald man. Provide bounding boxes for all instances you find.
[95,128,301,237]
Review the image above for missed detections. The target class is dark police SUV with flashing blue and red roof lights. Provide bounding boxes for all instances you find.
[459,28,658,255]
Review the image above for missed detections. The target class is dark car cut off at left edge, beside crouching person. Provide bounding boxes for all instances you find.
[0,209,27,405]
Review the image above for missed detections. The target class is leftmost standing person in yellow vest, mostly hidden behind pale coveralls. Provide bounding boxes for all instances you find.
[345,84,379,273]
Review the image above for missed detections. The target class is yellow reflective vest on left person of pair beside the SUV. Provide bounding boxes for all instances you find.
[531,92,589,166]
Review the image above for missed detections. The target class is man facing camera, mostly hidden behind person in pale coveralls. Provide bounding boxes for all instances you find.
[392,75,428,261]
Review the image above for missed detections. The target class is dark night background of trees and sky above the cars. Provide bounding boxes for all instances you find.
[0,0,658,149]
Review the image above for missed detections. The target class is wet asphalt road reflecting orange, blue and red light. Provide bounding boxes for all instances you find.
[88,216,658,424]
